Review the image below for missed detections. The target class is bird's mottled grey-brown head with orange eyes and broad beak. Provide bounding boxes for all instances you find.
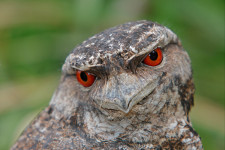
[50,21,194,120]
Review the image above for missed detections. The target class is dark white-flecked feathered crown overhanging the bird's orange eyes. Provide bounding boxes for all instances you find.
[63,21,177,70]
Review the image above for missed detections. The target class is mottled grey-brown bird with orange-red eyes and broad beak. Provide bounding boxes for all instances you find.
[11,20,203,150]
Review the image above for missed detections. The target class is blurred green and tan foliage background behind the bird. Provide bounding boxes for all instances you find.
[0,0,225,150]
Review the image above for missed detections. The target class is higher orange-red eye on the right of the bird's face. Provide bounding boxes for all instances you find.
[143,48,163,66]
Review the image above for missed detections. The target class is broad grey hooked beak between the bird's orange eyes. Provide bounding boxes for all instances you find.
[91,74,156,113]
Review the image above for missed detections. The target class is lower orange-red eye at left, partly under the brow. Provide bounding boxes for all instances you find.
[76,70,96,87]
